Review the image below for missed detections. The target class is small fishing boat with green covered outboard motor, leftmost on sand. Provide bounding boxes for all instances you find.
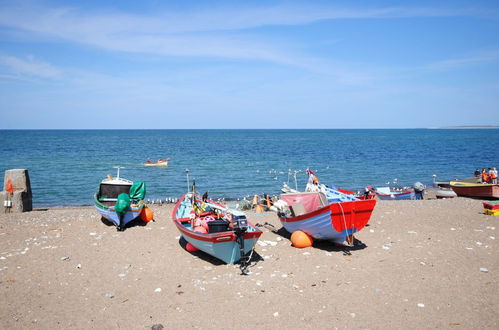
[94,166,147,231]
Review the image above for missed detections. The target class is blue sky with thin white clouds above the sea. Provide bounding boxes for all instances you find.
[0,0,499,129]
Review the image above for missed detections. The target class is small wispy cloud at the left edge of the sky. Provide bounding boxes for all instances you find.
[0,55,61,79]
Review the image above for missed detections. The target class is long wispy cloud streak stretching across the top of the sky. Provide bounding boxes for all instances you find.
[0,4,498,65]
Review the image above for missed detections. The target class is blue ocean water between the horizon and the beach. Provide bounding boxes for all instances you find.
[0,129,499,207]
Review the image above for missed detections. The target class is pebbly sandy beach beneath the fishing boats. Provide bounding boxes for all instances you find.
[0,198,499,329]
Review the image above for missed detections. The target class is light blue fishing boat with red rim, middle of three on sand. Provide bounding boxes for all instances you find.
[172,189,262,271]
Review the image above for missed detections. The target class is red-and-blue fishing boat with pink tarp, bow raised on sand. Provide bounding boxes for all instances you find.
[274,170,376,245]
